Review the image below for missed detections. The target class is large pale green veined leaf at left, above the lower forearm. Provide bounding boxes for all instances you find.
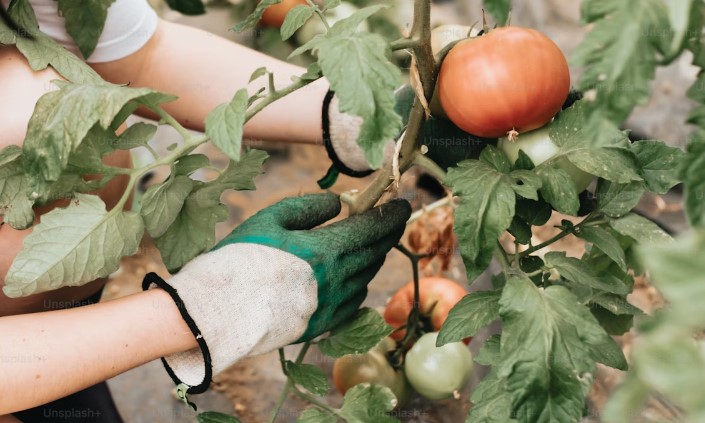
[3,194,144,298]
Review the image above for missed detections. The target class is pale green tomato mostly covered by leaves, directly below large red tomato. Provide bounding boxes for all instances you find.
[497,127,595,192]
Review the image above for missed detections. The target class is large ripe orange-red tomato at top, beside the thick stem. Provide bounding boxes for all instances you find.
[438,27,570,138]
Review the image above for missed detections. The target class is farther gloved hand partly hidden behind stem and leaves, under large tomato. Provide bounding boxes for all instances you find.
[319,85,496,188]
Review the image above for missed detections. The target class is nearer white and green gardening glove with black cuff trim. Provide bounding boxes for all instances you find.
[143,194,411,393]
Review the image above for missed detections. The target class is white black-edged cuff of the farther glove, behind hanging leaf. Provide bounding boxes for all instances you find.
[321,90,394,178]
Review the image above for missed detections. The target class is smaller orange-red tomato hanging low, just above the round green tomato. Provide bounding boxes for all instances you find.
[384,277,470,343]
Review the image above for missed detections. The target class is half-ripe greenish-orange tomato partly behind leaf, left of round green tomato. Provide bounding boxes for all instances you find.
[333,338,411,408]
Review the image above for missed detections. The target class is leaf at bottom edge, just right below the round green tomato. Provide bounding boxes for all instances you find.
[465,368,517,423]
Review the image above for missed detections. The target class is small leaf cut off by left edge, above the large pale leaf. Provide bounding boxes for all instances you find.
[0,145,34,230]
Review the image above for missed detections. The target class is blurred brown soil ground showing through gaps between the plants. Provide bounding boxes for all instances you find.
[106,0,694,423]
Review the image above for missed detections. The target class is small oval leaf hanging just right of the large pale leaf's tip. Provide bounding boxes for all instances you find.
[140,175,193,238]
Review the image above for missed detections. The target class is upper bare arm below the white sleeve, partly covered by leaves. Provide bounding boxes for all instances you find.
[91,21,328,143]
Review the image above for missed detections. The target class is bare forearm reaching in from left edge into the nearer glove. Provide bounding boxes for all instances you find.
[0,289,197,412]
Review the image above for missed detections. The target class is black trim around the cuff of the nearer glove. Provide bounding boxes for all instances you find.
[142,272,213,394]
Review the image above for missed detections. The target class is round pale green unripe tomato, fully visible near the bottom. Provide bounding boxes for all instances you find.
[404,332,473,400]
